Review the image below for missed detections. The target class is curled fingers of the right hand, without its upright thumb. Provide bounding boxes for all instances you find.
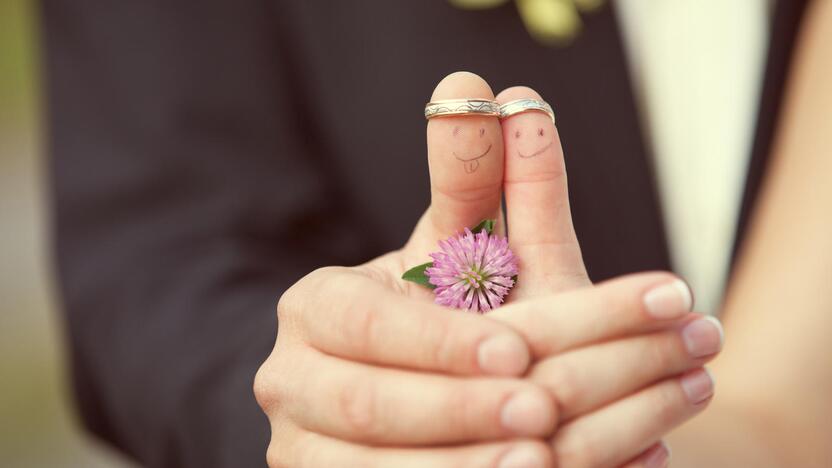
[489,273,722,468]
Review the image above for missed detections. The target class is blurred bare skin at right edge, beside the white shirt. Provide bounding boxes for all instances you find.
[671,1,832,468]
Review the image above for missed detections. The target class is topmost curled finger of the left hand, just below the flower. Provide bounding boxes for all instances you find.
[278,268,529,375]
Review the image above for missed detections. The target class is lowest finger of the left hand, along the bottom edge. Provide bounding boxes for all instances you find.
[269,426,553,468]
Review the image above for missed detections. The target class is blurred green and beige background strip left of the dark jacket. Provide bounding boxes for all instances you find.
[0,0,131,468]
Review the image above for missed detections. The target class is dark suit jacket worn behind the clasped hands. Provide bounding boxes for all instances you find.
[42,0,804,468]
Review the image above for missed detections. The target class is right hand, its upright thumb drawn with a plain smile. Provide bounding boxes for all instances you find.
[490,82,722,467]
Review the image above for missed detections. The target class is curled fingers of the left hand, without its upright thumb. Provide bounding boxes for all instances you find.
[255,267,555,468]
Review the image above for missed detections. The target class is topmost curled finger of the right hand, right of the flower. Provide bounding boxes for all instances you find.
[488,272,693,359]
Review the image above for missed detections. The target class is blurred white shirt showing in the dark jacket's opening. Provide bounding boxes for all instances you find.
[614,0,770,313]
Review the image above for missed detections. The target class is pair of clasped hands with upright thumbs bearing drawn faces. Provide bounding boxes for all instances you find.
[254,73,722,468]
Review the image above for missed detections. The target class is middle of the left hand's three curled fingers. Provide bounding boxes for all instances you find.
[282,352,556,445]
